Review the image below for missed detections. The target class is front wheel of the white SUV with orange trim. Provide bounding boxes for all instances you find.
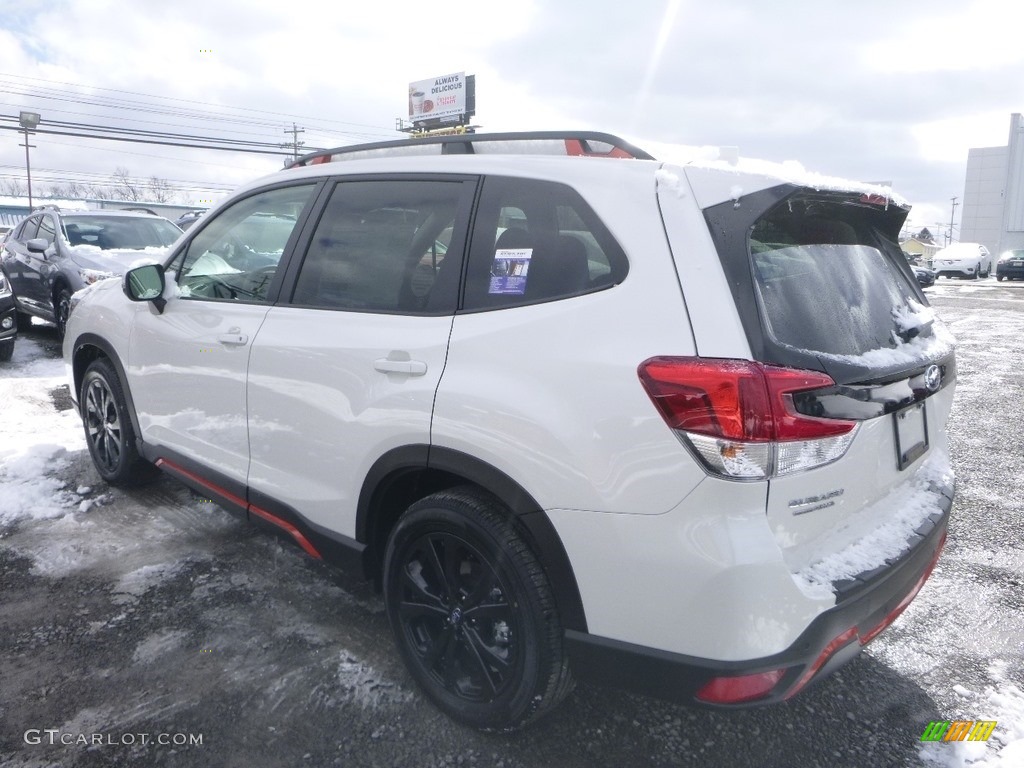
[79,357,157,485]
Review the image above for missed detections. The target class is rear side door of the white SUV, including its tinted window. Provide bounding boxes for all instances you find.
[246,176,476,537]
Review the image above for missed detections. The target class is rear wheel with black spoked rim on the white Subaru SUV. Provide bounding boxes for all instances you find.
[384,486,572,731]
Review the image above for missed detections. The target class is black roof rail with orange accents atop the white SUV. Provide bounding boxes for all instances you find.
[286,131,654,168]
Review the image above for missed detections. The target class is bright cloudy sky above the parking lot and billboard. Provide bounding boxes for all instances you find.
[0,0,1024,231]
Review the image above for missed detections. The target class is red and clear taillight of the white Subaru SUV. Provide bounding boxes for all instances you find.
[638,357,857,480]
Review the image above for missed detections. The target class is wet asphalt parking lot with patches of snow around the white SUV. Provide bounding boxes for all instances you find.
[0,279,1024,768]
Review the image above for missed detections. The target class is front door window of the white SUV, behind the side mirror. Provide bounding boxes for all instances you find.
[172,184,315,302]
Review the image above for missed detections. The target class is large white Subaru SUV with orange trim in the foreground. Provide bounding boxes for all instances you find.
[65,132,955,728]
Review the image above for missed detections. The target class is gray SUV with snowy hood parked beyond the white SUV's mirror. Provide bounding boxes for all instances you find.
[2,206,181,338]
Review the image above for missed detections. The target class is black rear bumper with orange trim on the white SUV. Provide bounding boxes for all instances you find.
[565,485,953,708]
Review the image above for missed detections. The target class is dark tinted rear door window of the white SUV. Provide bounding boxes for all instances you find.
[292,179,465,314]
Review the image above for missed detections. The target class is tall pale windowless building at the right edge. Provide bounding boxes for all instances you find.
[961,113,1024,254]
